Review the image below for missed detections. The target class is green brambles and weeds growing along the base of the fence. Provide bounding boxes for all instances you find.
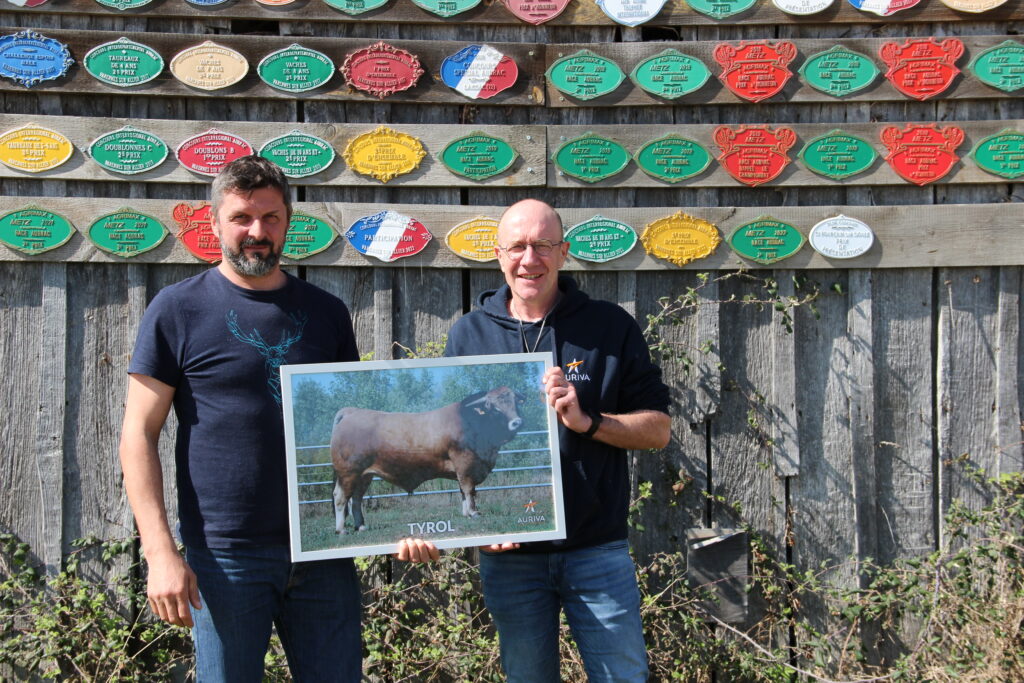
[0,463,1024,683]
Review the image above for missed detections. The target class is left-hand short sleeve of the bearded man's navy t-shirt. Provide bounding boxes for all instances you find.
[128,292,184,387]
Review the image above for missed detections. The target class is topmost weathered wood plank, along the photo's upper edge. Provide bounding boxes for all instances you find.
[0,0,1024,29]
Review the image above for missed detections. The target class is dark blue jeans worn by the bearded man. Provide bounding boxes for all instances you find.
[185,546,362,683]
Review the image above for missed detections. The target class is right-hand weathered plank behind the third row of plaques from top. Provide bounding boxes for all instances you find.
[546,119,1024,188]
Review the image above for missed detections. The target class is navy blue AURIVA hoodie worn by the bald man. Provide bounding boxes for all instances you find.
[444,274,670,552]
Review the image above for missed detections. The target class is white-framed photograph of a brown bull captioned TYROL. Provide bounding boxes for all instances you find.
[281,353,565,561]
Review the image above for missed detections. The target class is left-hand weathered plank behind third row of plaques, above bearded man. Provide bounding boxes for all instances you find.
[0,113,545,186]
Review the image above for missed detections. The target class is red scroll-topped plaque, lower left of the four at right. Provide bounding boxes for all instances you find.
[715,126,797,187]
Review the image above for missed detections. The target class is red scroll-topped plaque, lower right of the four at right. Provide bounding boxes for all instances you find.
[882,123,964,185]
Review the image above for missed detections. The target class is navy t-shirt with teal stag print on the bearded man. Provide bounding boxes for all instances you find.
[128,268,358,548]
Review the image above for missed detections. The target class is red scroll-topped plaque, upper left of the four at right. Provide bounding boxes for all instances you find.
[715,40,797,102]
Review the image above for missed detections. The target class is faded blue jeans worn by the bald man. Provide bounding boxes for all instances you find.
[480,541,647,683]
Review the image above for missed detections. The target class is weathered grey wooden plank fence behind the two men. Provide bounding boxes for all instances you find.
[0,0,1024,679]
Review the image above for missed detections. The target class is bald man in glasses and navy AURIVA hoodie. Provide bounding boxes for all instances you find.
[445,200,671,683]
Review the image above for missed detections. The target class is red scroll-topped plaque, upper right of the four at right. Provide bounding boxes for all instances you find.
[879,38,964,99]
